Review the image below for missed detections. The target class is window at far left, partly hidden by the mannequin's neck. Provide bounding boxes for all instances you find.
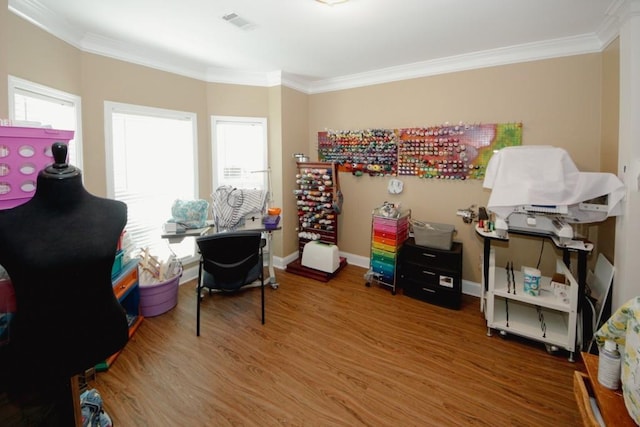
[9,76,82,169]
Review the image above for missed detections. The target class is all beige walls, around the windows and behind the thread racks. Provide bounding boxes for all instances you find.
[0,9,616,282]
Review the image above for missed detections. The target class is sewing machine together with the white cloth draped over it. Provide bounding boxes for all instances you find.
[483,146,625,241]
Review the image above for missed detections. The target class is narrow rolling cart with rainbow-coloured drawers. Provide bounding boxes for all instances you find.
[366,210,411,295]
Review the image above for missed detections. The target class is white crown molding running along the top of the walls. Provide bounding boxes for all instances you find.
[9,0,620,94]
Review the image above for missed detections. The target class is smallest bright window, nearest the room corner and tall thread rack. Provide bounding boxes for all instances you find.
[211,116,269,190]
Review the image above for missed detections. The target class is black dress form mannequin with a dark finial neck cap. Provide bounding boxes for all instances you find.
[0,143,128,424]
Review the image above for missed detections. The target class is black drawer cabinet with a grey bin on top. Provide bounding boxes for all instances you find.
[398,237,462,310]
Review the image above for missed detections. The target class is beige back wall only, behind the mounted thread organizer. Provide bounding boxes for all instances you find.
[308,55,602,282]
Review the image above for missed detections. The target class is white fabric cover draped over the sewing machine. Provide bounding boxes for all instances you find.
[483,145,624,222]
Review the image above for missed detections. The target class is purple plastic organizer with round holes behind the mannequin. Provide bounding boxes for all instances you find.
[0,126,73,209]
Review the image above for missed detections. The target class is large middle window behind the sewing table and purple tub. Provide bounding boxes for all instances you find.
[105,101,198,262]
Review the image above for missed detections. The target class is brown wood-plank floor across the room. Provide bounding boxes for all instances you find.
[90,266,584,426]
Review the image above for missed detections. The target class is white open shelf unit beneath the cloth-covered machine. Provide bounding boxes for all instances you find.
[484,249,579,361]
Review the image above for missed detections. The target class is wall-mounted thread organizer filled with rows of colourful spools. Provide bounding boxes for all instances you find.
[318,123,522,180]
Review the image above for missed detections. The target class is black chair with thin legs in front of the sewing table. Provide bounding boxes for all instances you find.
[196,231,266,336]
